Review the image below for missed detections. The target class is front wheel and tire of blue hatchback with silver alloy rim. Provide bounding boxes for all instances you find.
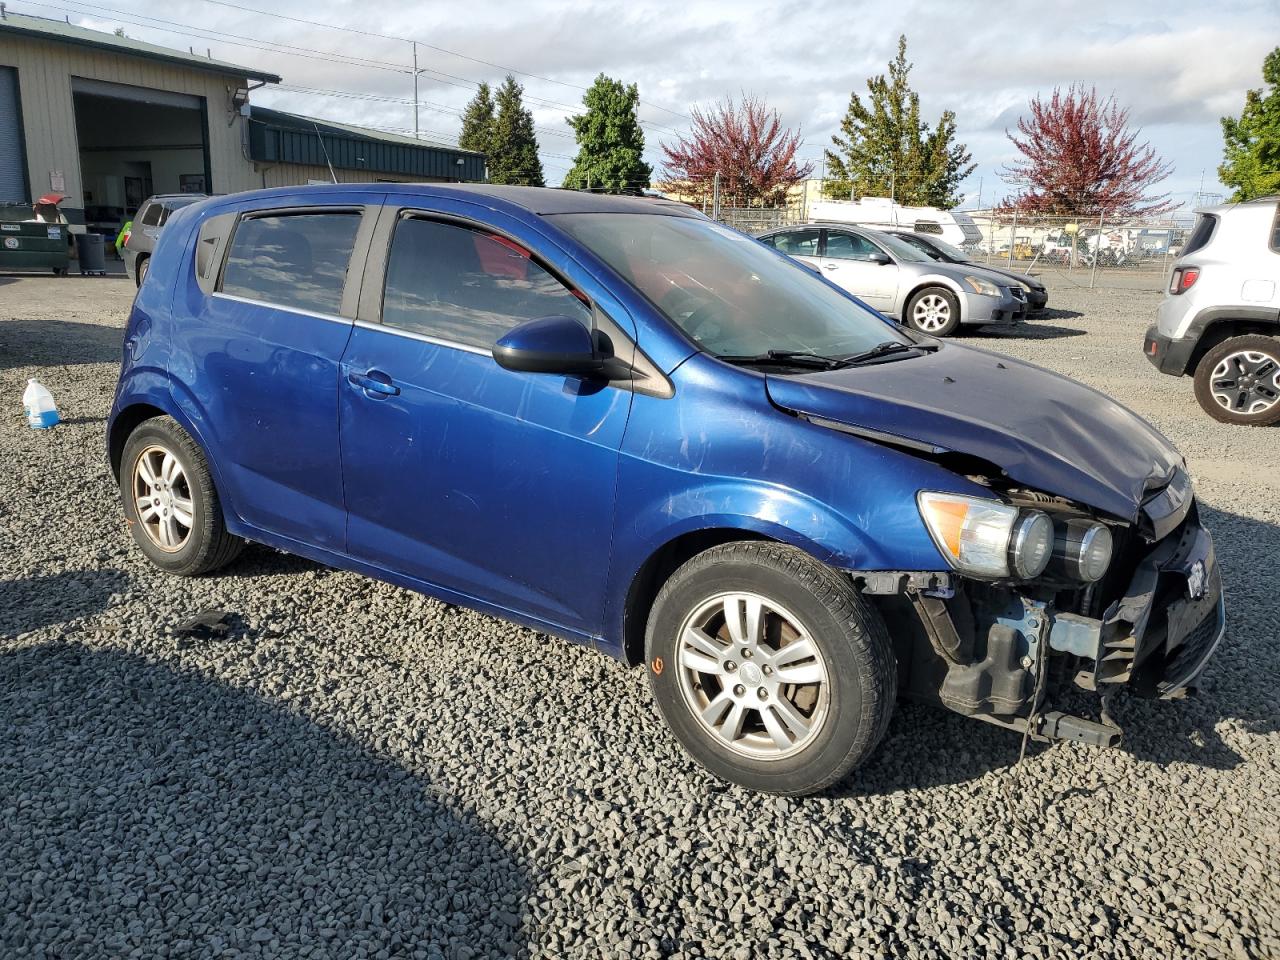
[645,541,897,795]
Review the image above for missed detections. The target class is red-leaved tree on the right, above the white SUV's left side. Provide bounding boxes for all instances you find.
[1001,86,1176,218]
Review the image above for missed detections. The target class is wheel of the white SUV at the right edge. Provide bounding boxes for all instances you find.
[1196,334,1280,426]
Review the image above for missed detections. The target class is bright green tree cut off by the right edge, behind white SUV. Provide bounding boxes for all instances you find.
[1217,47,1280,200]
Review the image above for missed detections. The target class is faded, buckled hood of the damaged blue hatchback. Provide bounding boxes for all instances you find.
[767,343,1183,521]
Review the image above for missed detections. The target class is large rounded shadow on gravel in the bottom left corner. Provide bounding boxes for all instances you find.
[0,644,529,957]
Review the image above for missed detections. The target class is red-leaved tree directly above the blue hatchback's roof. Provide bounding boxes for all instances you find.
[662,96,813,206]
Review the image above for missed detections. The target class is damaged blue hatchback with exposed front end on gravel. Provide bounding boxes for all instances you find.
[108,184,1224,794]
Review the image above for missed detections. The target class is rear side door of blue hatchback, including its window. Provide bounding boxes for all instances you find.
[174,195,380,552]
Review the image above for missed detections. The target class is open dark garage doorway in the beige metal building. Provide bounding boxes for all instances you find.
[72,77,210,238]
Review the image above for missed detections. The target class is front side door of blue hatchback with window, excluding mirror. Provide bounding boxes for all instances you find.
[339,201,632,635]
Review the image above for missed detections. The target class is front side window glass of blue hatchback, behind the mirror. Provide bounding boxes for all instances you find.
[383,218,591,349]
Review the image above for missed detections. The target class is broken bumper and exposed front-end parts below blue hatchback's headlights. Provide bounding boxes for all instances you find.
[885,502,1226,746]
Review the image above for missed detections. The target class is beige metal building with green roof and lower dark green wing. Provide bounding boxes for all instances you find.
[0,9,484,233]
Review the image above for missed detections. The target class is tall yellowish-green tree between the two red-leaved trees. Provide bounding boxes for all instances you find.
[824,36,974,207]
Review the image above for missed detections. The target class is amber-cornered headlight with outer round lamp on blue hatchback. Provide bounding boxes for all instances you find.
[916,492,1053,580]
